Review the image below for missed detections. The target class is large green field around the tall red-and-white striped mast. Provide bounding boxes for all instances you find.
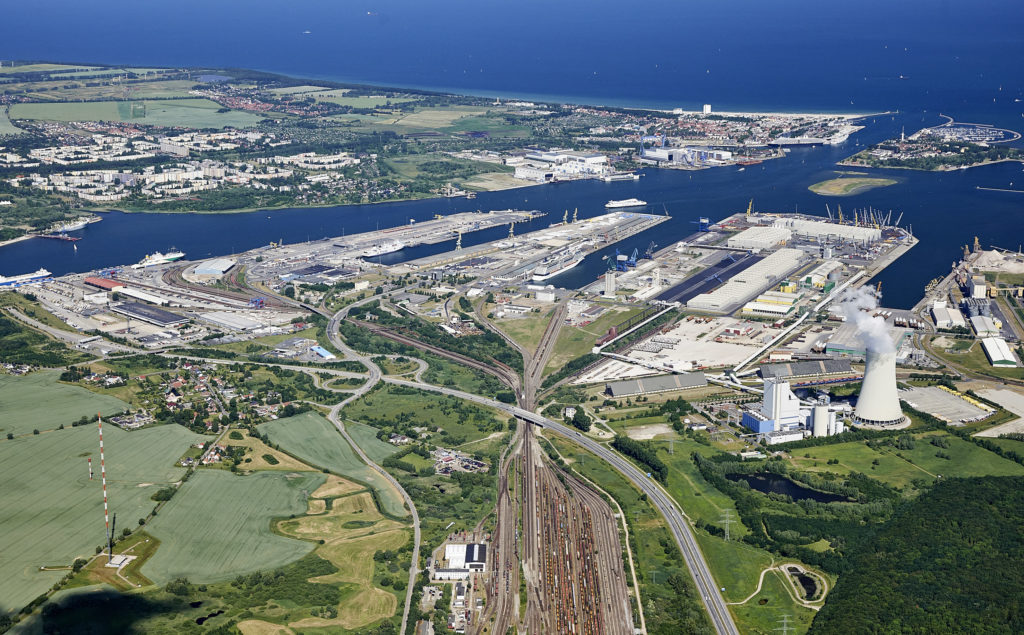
[0,425,201,611]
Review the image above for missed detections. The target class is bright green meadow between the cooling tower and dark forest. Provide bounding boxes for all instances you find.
[791,432,1024,490]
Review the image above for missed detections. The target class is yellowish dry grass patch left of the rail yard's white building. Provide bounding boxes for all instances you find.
[278,492,409,629]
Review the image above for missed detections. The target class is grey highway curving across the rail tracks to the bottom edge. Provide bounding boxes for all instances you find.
[384,377,739,635]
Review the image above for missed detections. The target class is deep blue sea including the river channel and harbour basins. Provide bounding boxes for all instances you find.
[0,0,1024,308]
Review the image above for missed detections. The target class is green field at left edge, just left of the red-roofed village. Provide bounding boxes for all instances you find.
[0,371,128,436]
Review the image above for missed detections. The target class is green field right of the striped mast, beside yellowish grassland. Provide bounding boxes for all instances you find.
[141,470,326,585]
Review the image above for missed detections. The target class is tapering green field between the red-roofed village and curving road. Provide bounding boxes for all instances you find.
[259,413,409,517]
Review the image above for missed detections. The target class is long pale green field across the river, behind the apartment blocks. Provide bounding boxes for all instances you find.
[10,99,263,128]
